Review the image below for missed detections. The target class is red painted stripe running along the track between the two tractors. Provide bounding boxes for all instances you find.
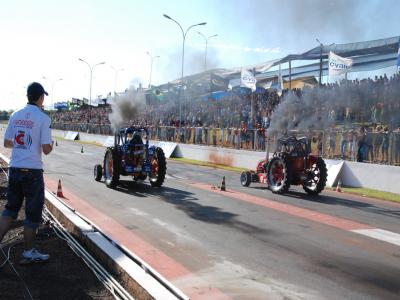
[189,182,374,230]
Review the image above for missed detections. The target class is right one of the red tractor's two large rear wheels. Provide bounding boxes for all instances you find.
[303,157,328,195]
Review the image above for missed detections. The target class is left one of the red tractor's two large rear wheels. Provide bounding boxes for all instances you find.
[267,156,291,194]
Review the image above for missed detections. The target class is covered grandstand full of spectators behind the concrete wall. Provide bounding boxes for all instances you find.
[52,37,400,164]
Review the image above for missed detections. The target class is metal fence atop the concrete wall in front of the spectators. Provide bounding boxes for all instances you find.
[52,123,400,165]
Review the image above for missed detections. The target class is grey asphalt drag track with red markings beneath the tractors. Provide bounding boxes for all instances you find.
[1,136,400,300]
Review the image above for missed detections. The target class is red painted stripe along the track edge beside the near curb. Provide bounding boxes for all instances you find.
[45,176,231,300]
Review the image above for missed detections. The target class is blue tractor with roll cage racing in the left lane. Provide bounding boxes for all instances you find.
[94,127,167,188]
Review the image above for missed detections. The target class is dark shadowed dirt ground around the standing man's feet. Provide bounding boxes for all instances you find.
[0,161,114,300]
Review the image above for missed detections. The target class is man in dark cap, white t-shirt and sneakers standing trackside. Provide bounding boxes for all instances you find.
[0,82,53,261]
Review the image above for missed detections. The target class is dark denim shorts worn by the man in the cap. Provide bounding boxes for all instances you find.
[3,168,44,228]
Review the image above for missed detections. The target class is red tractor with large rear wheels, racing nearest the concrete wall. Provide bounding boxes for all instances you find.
[240,136,328,195]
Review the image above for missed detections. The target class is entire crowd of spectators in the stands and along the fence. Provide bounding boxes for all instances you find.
[51,75,400,162]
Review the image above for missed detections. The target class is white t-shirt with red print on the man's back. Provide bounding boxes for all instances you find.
[4,104,51,169]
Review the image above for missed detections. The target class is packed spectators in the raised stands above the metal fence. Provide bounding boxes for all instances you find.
[52,75,400,129]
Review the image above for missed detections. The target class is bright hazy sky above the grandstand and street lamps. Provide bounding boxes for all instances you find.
[0,0,400,110]
